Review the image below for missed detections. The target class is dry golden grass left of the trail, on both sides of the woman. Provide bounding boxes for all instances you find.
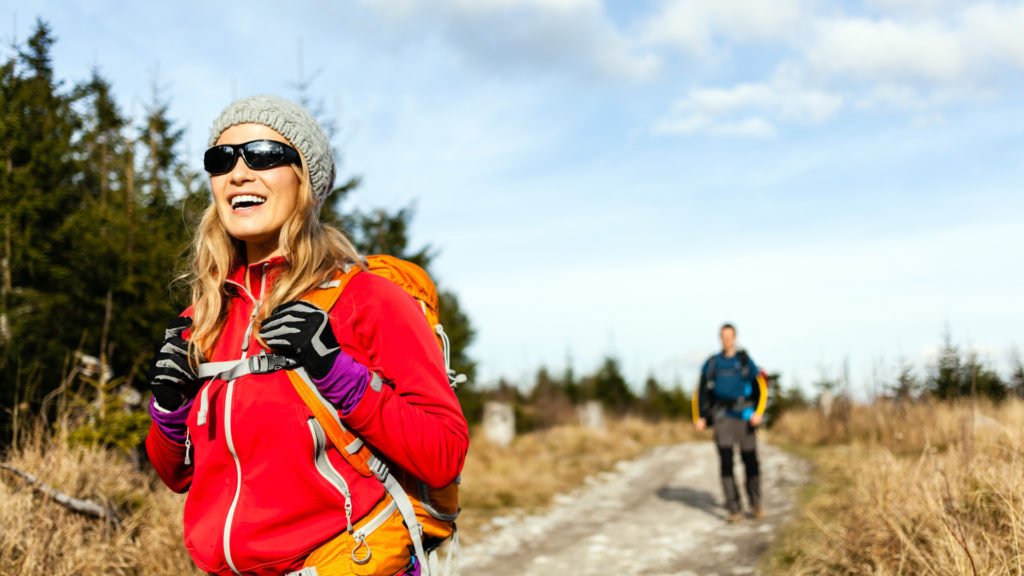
[0,412,692,576]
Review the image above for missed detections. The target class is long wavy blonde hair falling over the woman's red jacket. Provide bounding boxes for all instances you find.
[184,153,364,365]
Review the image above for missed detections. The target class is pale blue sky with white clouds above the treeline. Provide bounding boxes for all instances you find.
[0,0,1024,394]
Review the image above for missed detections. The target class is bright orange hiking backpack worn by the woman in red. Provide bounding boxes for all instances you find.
[288,255,465,576]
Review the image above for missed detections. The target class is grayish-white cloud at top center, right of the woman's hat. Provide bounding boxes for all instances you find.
[364,0,659,79]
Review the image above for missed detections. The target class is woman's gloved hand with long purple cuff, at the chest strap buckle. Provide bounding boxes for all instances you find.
[259,300,371,414]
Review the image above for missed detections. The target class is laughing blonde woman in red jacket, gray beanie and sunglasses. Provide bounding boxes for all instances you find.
[146,96,469,576]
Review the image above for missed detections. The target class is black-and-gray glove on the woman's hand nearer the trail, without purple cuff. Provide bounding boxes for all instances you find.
[259,301,341,379]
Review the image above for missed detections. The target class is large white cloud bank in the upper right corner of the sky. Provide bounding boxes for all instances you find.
[640,0,1024,136]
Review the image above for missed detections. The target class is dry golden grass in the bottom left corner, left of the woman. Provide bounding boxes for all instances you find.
[0,420,199,576]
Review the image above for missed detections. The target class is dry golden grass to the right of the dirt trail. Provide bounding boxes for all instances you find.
[765,402,1024,575]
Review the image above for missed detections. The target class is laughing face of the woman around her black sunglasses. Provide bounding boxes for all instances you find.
[210,124,301,263]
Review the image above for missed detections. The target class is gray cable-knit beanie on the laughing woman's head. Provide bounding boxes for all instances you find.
[210,95,334,203]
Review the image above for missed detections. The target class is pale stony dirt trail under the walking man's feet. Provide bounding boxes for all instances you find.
[459,442,809,576]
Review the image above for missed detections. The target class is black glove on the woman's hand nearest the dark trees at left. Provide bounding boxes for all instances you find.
[145,317,199,411]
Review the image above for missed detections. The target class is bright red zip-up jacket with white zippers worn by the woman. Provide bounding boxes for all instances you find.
[146,258,469,575]
